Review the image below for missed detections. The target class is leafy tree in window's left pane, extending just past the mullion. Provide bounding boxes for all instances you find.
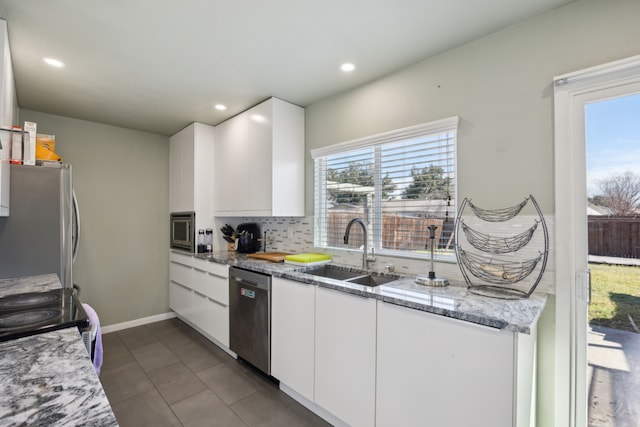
[327,162,396,204]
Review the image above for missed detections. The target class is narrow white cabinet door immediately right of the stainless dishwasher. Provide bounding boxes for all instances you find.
[271,277,316,401]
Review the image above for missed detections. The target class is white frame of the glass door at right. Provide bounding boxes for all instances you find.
[554,57,640,426]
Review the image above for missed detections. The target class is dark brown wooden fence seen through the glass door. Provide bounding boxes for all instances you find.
[588,215,640,258]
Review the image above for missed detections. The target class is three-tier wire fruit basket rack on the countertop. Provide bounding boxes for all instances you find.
[455,195,549,299]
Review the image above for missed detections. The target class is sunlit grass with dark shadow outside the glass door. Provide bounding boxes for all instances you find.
[589,264,640,332]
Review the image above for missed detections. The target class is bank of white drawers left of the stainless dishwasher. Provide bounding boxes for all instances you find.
[169,252,229,348]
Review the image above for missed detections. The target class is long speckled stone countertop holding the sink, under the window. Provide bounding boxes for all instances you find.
[194,251,547,334]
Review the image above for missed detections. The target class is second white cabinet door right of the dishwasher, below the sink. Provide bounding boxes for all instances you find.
[315,288,378,427]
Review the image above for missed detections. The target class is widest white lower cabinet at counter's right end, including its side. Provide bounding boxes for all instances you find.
[376,301,535,427]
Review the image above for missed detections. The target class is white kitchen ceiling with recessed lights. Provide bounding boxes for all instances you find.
[0,0,573,135]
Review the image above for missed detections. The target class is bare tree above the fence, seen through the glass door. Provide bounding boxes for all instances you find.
[593,171,640,215]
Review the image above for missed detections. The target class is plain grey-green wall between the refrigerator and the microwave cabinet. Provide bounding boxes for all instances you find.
[20,109,169,326]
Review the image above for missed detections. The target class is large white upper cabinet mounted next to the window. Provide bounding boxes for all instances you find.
[214,98,304,216]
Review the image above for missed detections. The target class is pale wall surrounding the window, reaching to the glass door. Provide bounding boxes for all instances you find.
[305,0,640,426]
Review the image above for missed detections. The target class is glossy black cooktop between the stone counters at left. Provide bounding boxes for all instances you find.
[0,288,89,341]
